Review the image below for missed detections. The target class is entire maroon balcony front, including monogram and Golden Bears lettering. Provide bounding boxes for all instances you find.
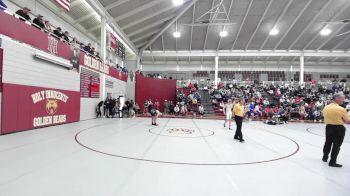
[0,12,128,81]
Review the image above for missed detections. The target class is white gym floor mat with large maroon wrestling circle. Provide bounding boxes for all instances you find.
[0,118,350,196]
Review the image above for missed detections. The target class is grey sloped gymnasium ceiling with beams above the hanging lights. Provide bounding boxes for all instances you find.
[48,0,350,63]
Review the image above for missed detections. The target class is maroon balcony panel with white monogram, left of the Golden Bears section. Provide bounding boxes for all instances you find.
[0,12,71,60]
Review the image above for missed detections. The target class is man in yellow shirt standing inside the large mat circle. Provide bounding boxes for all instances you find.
[233,98,245,142]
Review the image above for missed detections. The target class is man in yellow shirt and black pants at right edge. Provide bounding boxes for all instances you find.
[322,93,350,167]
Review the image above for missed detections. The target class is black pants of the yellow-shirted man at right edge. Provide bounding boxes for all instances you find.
[323,125,345,163]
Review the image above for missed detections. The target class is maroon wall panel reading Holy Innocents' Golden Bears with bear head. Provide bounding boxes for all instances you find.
[1,83,80,134]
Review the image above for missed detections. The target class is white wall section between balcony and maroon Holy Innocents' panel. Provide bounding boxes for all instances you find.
[1,39,80,91]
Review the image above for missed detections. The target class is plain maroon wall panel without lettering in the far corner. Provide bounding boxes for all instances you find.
[135,74,176,112]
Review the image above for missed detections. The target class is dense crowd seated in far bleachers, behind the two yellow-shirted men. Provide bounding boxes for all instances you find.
[209,82,350,123]
